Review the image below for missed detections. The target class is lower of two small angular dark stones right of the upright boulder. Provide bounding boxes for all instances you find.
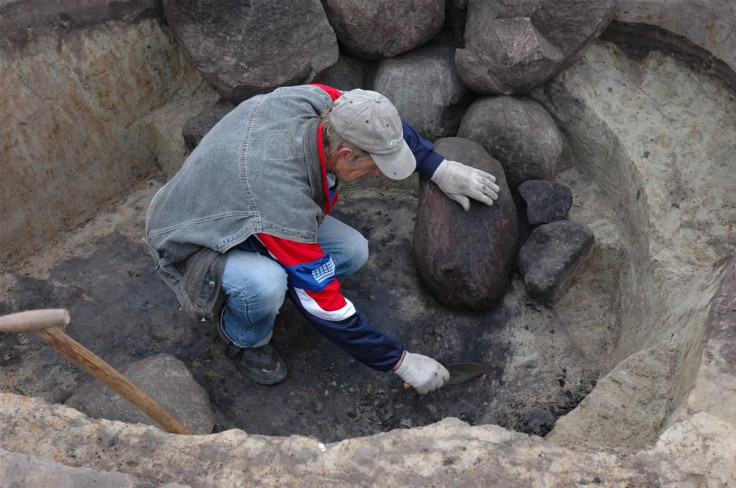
[519,220,595,304]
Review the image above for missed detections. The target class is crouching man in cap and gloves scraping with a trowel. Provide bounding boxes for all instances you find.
[146,85,498,394]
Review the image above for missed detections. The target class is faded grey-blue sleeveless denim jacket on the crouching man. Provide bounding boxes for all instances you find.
[146,86,332,320]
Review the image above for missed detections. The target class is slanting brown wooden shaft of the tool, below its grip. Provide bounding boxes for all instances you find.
[36,328,192,434]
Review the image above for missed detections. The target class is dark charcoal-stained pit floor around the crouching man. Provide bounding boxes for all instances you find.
[0,173,616,442]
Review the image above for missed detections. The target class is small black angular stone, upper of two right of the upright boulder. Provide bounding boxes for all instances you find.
[519,180,572,225]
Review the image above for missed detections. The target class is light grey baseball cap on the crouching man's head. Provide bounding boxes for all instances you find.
[330,89,417,180]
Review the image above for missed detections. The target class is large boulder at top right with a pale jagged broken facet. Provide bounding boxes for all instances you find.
[456,0,616,94]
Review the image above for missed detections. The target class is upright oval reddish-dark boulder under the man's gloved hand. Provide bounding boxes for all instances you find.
[414,138,519,309]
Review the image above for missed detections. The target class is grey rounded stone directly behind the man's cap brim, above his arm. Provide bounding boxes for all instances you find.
[373,43,473,140]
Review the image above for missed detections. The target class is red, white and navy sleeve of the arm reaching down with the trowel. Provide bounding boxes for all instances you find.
[257,234,404,371]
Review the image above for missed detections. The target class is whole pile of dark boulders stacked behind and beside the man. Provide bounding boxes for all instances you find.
[164,0,615,309]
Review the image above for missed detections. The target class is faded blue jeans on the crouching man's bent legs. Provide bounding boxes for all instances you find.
[220,215,368,347]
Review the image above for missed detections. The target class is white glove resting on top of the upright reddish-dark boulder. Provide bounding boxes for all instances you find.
[431,159,501,212]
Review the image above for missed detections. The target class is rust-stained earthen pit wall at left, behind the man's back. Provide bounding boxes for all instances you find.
[0,9,216,265]
